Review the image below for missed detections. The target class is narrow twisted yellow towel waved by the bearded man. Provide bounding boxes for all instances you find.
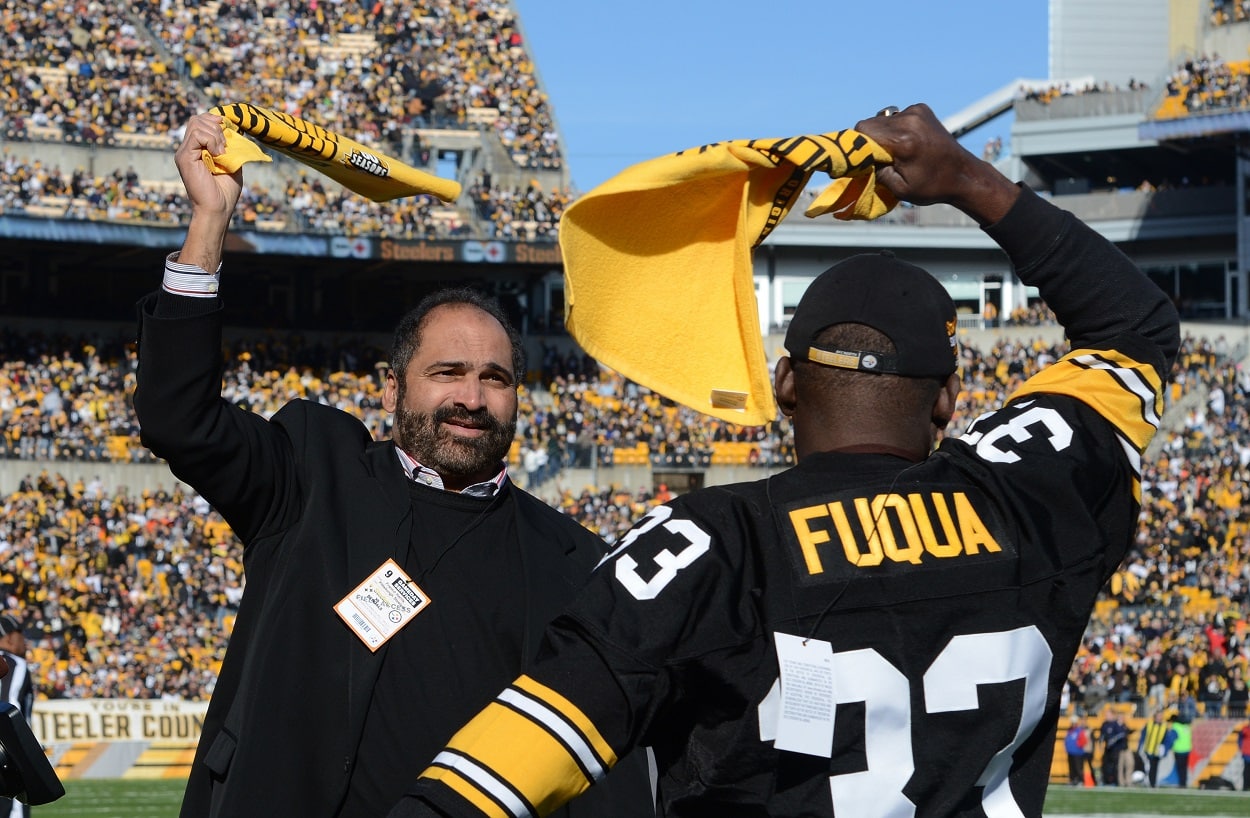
[204,103,460,201]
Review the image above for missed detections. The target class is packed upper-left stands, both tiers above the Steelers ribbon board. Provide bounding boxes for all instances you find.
[0,0,568,240]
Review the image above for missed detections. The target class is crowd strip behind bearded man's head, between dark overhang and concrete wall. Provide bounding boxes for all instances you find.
[0,322,789,470]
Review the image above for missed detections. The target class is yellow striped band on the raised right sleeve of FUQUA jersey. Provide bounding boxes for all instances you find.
[1011,349,1163,452]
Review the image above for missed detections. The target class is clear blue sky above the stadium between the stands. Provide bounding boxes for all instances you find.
[514,0,1048,191]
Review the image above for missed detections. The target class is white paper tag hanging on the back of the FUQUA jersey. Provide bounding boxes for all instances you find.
[773,633,836,758]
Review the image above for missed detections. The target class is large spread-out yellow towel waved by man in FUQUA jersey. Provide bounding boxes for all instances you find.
[560,130,898,425]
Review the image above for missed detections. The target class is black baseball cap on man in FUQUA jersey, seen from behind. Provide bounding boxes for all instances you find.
[785,250,959,378]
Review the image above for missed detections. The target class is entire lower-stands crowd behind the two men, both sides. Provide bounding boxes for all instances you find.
[0,331,1250,715]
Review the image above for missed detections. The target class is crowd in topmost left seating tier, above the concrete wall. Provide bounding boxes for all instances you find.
[0,0,563,169]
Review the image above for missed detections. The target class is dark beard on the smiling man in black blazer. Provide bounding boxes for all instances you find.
[393,405,516,477]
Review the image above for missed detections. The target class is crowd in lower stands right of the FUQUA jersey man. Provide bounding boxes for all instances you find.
[1069,332,1250,718]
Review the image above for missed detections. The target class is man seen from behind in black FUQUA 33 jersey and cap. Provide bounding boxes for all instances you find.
[390,105,1179,818]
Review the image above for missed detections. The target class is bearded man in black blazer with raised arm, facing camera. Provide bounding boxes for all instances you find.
[135,114,649,818]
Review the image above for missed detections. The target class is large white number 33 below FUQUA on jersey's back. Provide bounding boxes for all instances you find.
[760,625,1053,818]
